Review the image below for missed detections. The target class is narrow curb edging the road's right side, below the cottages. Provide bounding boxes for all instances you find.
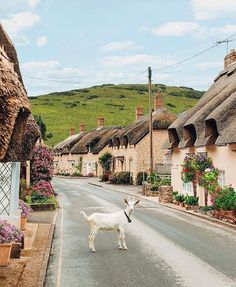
[88,182,236,231]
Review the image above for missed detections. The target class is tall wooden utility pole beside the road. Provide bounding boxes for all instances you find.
[148,67,153,174]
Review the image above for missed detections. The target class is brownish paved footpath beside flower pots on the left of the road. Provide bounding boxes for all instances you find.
[0,211,57,287]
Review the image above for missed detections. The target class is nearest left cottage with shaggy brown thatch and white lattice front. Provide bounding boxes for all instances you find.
[0,24,40,225]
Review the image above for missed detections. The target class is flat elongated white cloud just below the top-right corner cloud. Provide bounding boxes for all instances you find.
[143,21,200,37]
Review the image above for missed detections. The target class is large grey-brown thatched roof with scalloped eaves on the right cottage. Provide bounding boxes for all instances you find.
[169,59,236,148]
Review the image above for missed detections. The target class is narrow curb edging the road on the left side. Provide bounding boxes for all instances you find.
[37,208,58,287]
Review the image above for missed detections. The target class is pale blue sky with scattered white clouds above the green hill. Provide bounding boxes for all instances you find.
[0,0,236,96]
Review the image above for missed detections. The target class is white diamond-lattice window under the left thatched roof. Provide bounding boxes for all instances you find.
[0,162,12,215]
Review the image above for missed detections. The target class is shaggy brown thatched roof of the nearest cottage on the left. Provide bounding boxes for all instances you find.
[0,25,40,161]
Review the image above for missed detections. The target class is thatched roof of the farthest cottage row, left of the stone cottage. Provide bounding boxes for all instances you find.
[54,127,121,154]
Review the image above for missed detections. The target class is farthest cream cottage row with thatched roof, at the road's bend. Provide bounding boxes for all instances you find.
[54,116,120,176]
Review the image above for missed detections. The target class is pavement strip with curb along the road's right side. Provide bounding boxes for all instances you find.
[89,177,236,232]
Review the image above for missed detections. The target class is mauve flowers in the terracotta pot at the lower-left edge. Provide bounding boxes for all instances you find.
[0,222,23,243]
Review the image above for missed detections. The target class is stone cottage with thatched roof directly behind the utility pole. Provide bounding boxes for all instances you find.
[108,93,176,182]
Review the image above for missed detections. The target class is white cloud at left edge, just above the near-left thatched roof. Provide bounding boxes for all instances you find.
[1,11,40,36]
